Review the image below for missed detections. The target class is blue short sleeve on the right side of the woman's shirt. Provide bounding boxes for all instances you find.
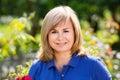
[93,58,112,80]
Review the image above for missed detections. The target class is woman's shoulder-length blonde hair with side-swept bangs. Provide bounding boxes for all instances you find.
[38,6,85,61]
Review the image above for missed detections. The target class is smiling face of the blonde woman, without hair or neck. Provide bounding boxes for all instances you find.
[48,19,74,53]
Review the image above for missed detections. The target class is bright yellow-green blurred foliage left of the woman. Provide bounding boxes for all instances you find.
[0,13,39,61]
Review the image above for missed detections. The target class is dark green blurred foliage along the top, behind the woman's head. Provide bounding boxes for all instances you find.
[0,0,120,19]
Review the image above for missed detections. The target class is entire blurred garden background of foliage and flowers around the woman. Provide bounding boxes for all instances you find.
[0,0,120,80]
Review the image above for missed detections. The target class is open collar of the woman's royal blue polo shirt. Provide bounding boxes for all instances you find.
[48,53,79,68]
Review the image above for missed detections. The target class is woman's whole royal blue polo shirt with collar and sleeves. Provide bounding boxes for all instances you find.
[29,54,112,80]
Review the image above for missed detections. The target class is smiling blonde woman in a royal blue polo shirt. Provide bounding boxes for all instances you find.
[29,6,111,80]
